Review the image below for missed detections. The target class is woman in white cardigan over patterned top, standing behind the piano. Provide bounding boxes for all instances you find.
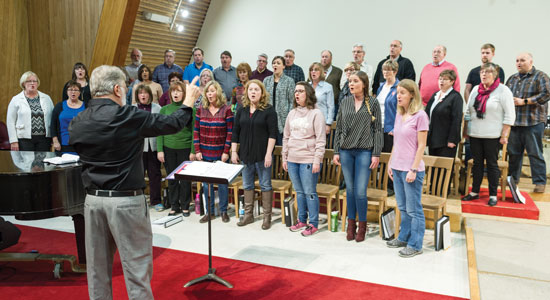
[6,71,53,151]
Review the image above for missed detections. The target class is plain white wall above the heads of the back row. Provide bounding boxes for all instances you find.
[197,0,550,90]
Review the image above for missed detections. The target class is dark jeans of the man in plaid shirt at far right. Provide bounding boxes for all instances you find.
[508,123,546,185]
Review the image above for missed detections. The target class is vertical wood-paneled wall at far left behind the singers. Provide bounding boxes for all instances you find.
[0,0,103,121]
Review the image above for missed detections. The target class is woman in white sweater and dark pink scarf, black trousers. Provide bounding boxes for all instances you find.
[462,63,516,206]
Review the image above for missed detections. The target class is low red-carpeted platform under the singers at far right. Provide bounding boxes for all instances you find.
[461,188,539,220]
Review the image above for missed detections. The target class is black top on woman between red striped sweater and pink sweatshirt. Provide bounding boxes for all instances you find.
[231,105,279,164]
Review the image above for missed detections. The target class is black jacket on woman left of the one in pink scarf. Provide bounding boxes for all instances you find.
[426,89,464,149]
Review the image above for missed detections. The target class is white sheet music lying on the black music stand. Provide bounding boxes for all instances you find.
[170,161,244,184]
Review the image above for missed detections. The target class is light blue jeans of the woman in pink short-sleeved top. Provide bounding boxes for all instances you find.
[392,169,426,250]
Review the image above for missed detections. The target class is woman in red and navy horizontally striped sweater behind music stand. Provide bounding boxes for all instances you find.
[193,81,233,223]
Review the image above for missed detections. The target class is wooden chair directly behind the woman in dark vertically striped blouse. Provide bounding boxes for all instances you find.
[342,152,390,236]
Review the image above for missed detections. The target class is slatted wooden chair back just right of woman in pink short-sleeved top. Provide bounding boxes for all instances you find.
[423,155,454,198]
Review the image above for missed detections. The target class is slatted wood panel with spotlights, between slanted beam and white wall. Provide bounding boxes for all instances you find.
[125,0,210,70]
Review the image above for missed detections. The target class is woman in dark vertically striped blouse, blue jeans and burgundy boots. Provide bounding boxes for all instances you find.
[333,71,384,242]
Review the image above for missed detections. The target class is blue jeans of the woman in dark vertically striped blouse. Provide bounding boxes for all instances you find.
[340,149,372,222]
